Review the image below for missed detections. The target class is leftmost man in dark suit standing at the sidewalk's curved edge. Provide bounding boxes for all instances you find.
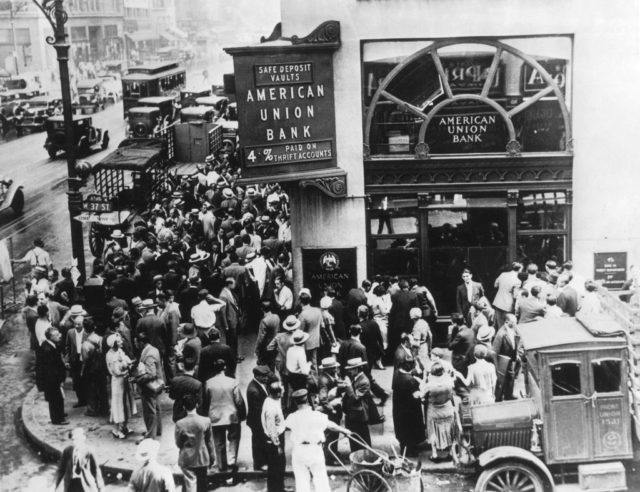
[38,326,69,425]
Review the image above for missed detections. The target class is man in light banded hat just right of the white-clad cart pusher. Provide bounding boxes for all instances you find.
[318,357,345,466]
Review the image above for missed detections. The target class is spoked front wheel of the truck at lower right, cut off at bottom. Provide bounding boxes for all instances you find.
[475,461,546,492]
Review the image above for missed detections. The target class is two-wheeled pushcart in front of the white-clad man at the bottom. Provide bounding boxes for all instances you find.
[329,434,424,492]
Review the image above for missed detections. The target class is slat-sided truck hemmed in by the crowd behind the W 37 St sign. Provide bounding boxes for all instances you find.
[78,138,172,256]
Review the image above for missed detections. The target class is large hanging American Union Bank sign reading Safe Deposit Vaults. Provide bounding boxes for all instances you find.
[234,51,336,176]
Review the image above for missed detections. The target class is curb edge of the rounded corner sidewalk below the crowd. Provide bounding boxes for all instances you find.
[18,387,464,484]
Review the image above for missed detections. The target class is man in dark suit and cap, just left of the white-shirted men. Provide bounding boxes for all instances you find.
[247,366,275,471]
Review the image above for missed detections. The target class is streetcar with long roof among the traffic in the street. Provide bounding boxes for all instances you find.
[122,61,187,118]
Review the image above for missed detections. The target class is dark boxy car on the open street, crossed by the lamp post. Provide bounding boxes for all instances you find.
[44,115,109,159]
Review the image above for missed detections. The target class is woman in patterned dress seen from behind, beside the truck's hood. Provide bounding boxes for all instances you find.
[423,362,457,461]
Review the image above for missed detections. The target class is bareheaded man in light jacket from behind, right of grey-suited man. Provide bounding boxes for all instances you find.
[203,360,247,472]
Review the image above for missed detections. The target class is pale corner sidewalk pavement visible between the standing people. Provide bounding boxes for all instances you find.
[22,330,456,483]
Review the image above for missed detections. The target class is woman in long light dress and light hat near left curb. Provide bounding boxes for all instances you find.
[106,333,136,439]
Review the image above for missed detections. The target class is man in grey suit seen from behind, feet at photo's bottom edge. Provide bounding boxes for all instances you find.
[175,395,213,492]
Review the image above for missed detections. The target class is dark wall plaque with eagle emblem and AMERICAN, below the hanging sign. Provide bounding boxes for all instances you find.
[302,248,358,300]
